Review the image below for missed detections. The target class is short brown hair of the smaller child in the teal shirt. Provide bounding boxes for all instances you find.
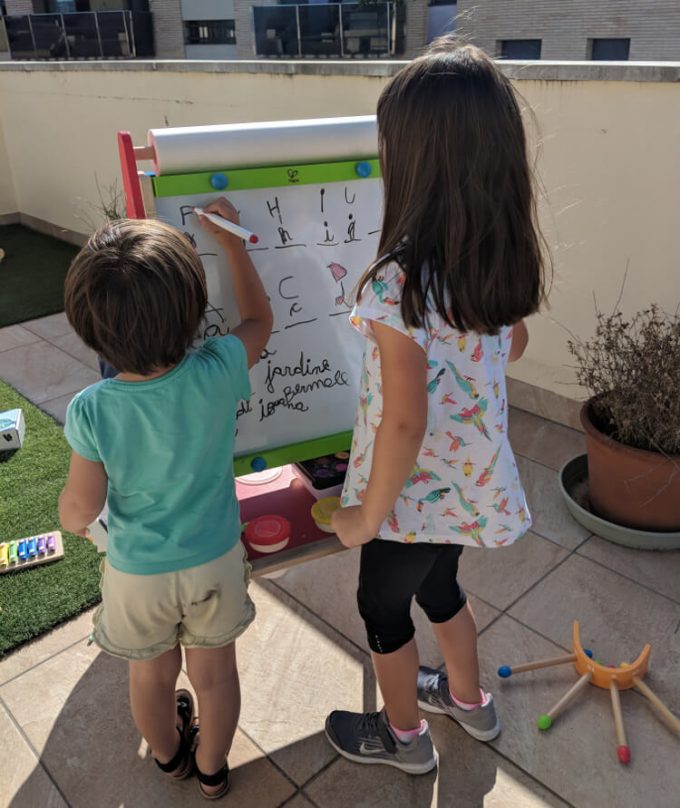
[64,219,208,375]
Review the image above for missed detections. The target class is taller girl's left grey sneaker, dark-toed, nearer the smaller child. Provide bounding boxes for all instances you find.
[326,709,437,774]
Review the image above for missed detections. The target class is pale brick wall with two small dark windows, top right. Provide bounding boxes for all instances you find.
[454,0,680,61]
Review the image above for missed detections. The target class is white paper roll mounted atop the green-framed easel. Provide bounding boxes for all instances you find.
[148,115,378,175]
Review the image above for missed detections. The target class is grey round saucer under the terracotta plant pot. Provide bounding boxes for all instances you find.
[559,455,680,550]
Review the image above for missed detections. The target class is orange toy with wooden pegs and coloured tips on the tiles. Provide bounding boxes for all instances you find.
[498,620,680,764]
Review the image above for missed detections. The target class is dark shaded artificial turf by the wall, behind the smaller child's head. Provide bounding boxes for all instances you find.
[0,224,78,328]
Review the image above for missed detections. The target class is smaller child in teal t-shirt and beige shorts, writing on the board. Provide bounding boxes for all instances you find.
[59,199,272,799]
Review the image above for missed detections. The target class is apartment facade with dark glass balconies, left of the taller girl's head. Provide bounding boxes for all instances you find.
[4,0,456,59]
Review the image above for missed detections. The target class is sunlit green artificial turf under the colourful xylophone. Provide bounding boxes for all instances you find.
[0,381,101,657]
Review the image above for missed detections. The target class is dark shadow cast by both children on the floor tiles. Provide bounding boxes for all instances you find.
[9,636,508,808]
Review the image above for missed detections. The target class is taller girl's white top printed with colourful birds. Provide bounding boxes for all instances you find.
[342,264,531,547]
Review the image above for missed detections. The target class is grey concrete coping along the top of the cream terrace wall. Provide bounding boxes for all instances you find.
[0,59,680,83]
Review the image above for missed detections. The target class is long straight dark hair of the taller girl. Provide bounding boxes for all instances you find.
[359,37,545,334]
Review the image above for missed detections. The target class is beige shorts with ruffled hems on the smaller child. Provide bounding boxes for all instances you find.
[91,542,255,660]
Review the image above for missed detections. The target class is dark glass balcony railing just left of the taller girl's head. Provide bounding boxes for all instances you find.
[253,3,403,58]
